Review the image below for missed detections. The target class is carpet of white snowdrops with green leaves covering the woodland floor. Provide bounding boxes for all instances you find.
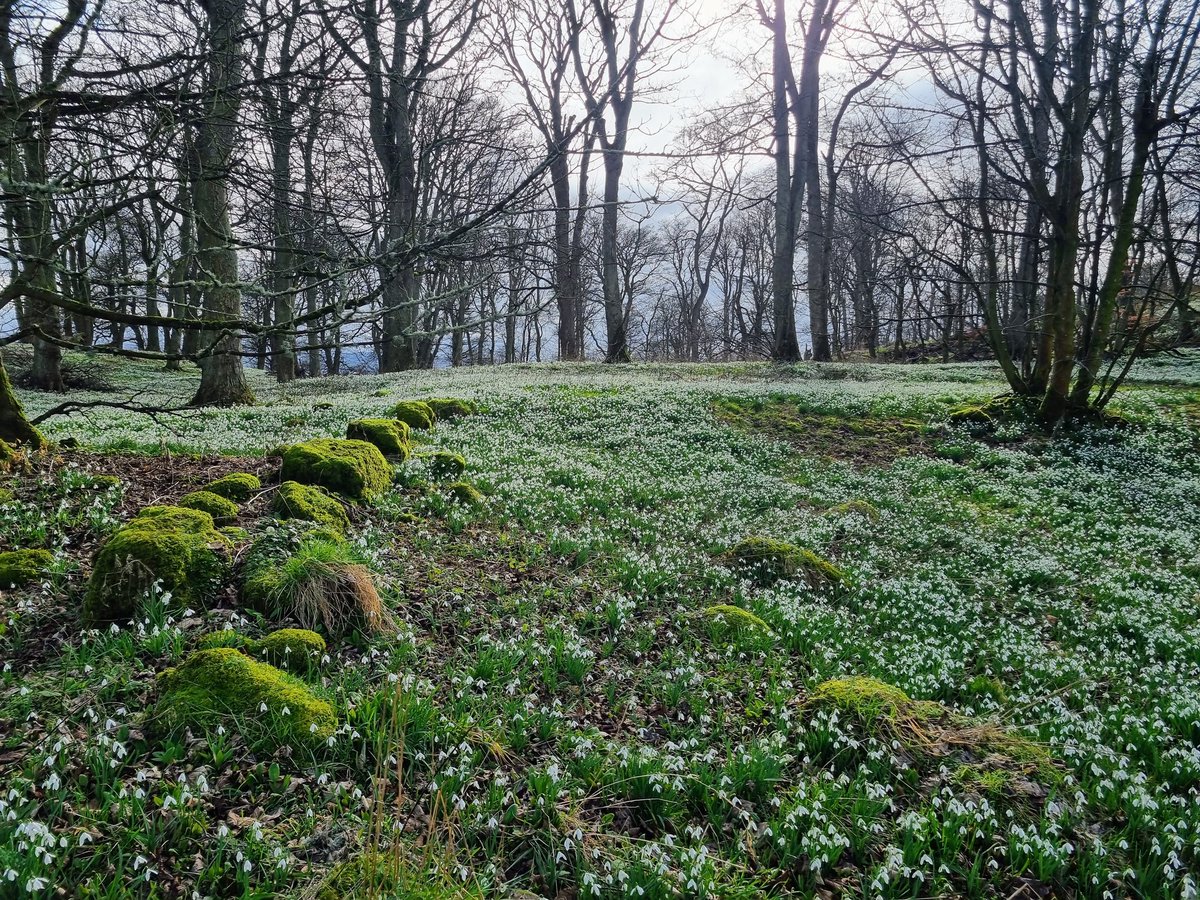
[0,356,1200,898]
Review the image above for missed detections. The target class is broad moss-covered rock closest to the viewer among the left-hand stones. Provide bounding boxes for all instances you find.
[155,647,337,750]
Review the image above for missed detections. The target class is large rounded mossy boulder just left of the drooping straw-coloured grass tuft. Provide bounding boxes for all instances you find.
[83,506,230,624]
